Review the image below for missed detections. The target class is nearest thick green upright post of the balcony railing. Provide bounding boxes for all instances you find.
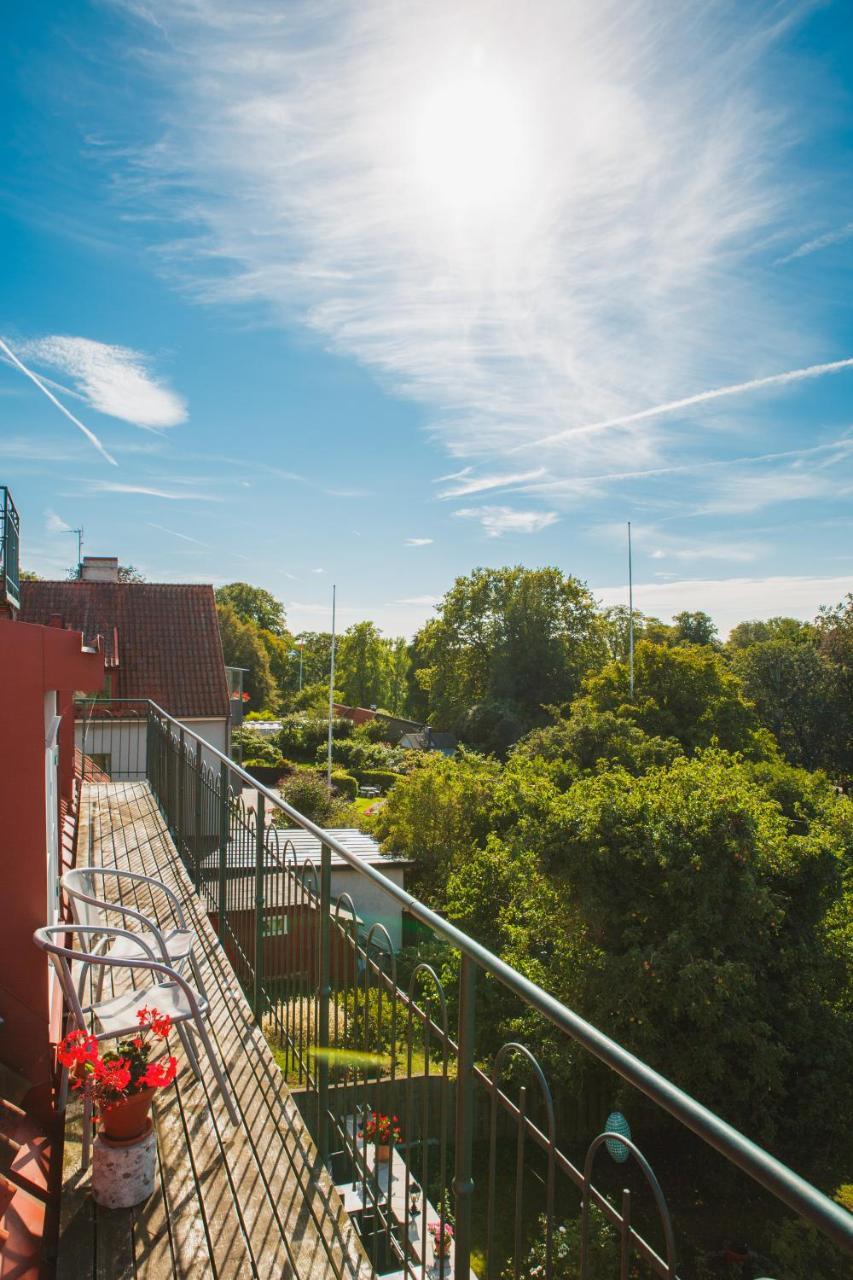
[453,955,476,1280]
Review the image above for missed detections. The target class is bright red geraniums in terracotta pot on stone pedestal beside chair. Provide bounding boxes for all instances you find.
[59,1009,178,1143]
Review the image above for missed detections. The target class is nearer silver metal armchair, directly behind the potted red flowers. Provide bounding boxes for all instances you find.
[33,924,240,1169]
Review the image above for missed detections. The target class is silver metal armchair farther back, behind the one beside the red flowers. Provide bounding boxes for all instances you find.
[60,867,207,998]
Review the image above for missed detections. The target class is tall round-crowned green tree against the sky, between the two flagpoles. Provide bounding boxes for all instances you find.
[416,566,603,730]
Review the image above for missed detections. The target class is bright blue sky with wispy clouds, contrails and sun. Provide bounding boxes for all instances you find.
[0,0,853,634]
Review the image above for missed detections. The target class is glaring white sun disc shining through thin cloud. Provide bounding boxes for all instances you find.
[415,70,532,214]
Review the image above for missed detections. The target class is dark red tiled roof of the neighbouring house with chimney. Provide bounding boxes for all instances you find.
[19,581,228,719]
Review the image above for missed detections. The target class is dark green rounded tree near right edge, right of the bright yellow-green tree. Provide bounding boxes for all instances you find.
[731,640,849,772]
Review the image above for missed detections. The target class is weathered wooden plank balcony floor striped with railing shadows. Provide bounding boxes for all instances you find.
[58,782,373,1280]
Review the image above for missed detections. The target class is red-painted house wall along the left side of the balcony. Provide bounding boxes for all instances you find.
[0,620,104,1084]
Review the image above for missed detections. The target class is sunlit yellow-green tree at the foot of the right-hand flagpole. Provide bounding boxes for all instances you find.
[584,640,758,751]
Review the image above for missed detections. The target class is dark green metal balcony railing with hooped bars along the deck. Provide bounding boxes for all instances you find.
[77,701,853,1280]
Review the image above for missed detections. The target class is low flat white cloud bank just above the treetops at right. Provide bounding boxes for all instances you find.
[593,576,850,635]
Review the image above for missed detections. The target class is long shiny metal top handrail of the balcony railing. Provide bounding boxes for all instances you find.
[73,698,853,1252]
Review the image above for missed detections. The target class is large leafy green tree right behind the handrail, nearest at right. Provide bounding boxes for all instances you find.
[517,750,853,1153]
